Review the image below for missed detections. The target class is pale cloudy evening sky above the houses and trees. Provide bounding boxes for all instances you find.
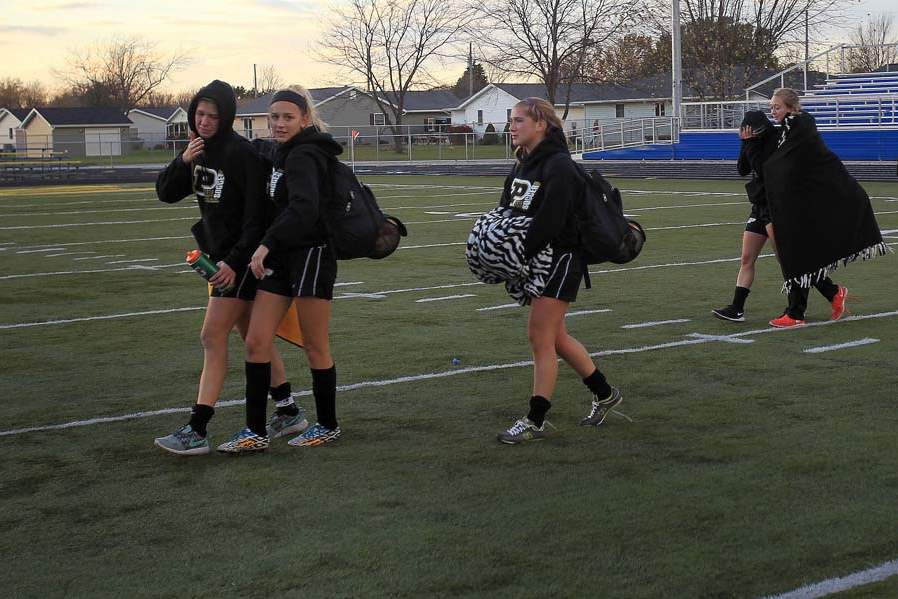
[0,0,898,91]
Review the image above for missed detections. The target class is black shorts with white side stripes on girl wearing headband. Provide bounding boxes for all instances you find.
[258,245,337,300]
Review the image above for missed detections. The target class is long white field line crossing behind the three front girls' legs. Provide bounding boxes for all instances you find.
[0,310,898,437]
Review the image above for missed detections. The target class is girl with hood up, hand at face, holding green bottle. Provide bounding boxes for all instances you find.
[155,80,301,455]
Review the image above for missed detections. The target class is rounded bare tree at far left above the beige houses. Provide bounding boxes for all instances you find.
[62,37,187,110]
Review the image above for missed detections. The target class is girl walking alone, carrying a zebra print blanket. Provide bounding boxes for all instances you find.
[497,98,622,445]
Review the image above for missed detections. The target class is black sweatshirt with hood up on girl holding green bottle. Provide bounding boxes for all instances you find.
[156,80,267,270]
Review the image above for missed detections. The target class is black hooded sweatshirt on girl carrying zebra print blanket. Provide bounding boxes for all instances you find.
[499,127,584,259]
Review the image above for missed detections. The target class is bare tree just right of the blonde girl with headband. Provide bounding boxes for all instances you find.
[317,0,471,151]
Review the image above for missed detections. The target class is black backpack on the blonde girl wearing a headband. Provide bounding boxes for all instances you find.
[323,157,408,260]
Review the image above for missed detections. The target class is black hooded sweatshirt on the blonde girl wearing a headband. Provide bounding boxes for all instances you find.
[262,126,343,253]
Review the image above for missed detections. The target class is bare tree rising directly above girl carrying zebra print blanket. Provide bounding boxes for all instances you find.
[476,0,633,118]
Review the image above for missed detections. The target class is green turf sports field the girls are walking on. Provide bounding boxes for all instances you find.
[0,176,898,599]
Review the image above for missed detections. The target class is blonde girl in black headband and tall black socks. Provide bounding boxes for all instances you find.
[218,87,342,453]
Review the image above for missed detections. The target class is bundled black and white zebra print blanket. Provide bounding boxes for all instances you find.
[465,208,552,306]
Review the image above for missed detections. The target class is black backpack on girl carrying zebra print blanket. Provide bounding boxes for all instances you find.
[576,164,645,268]
